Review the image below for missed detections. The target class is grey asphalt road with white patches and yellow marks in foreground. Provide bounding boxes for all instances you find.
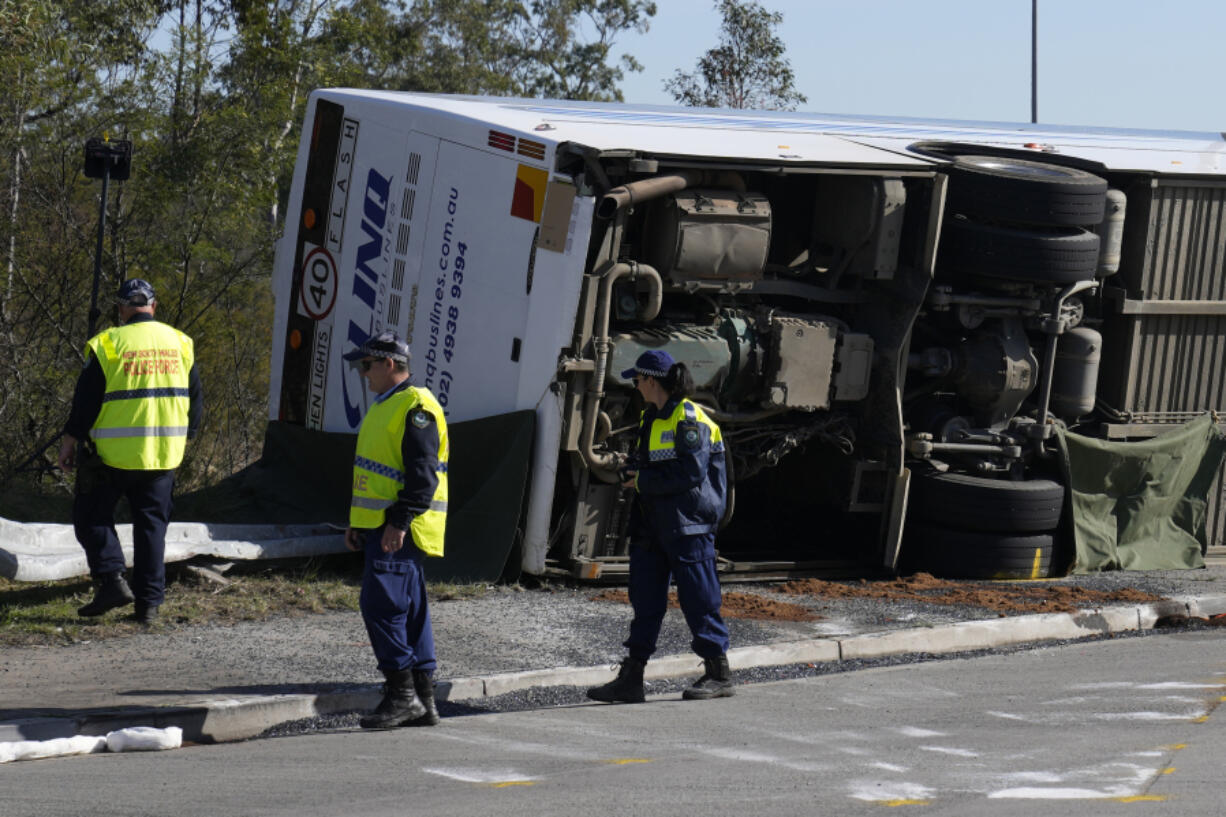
[0,631,1226,817]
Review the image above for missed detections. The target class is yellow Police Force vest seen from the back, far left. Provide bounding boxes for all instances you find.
[86,320,195,471]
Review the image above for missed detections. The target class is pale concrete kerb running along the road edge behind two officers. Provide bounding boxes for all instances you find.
[0,581,1226,743]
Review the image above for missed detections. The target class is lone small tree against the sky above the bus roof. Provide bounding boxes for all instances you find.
[664,0,808,110]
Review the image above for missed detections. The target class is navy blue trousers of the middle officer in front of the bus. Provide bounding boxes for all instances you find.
[358,527,438,672]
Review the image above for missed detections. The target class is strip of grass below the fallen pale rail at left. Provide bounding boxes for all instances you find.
[0,554,488,646]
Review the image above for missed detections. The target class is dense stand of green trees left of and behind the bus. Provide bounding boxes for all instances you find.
[0,0,655,518]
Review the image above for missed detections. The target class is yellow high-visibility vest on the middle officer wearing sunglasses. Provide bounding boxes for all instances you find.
[349,386,450,556]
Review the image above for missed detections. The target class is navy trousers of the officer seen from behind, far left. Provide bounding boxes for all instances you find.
[72,460,174,607]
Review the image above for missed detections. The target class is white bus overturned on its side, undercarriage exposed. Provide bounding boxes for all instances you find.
[270,90,1226,580]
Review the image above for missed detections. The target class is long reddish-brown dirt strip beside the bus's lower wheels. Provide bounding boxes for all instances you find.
[777,573,1162,616]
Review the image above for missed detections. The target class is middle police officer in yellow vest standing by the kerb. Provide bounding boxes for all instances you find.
[345,331,449,729]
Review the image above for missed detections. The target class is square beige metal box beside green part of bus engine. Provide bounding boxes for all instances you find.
[764,316,839,411]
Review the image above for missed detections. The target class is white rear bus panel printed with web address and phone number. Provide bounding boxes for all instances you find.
[411,141,568,421]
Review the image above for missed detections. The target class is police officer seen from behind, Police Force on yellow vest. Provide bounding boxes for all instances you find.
[59,278,204,624]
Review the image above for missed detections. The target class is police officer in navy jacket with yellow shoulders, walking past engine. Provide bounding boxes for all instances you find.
[587,350,733,703]
